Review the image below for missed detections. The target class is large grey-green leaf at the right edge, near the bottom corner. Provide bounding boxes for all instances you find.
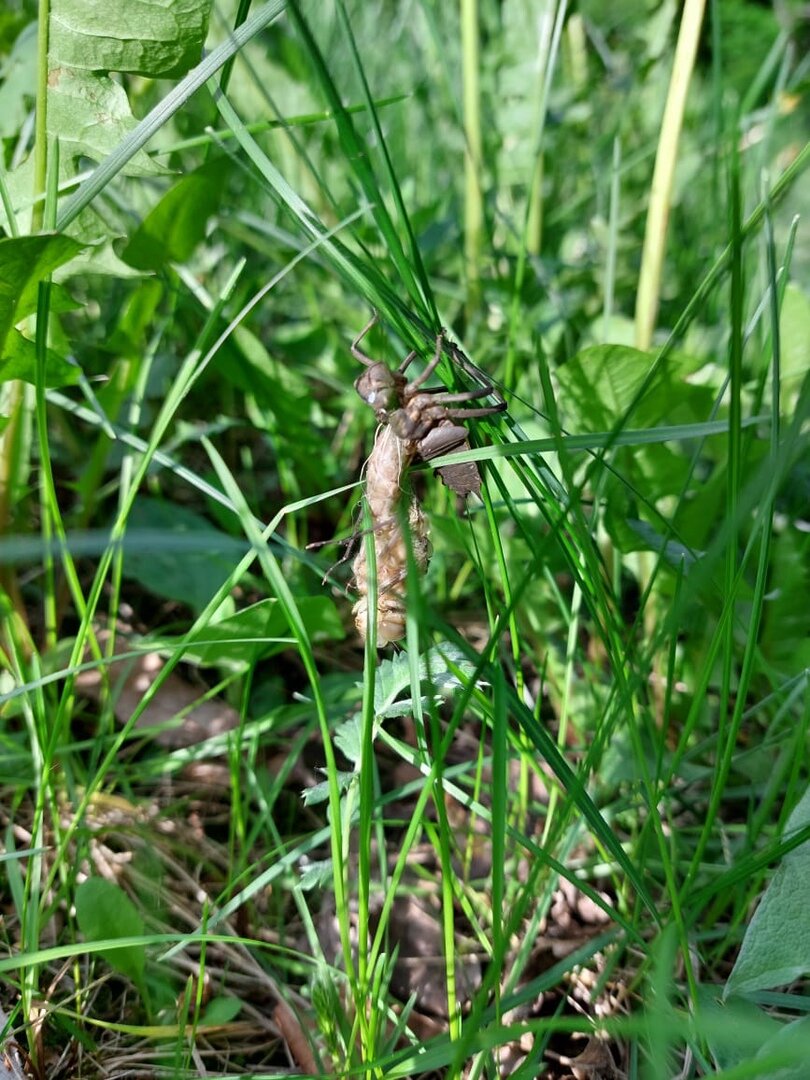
[724,787,810,997]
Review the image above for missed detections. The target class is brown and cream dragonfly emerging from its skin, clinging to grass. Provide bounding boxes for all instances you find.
[351,314,507,647]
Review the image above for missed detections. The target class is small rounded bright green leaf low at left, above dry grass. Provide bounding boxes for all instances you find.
[76,877,146,986]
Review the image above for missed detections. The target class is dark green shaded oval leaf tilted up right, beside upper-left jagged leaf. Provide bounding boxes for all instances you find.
[122,159,227,270]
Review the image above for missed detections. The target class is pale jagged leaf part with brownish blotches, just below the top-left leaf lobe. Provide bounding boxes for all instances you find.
[48,67,165,176]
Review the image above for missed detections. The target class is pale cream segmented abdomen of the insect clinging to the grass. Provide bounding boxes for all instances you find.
[352,424,429,646]
